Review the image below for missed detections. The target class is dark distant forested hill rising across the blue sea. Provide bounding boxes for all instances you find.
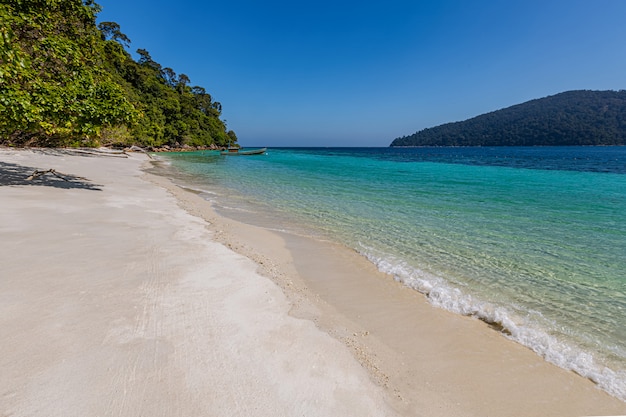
[390,90,626,146]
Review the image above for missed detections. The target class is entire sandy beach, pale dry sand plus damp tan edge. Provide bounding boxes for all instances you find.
[0,150,626,417]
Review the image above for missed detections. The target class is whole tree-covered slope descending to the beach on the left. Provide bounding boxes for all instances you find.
[0,0,237,147]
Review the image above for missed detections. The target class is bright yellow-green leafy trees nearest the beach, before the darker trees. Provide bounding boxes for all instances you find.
[0,0,136,146]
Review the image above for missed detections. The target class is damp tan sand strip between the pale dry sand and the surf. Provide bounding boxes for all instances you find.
[150,154,626,416]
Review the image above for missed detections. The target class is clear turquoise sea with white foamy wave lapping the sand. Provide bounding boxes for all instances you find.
[156,147,626,400]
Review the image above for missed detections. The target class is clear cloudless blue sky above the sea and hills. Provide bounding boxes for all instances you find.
[97,0,626,146]
